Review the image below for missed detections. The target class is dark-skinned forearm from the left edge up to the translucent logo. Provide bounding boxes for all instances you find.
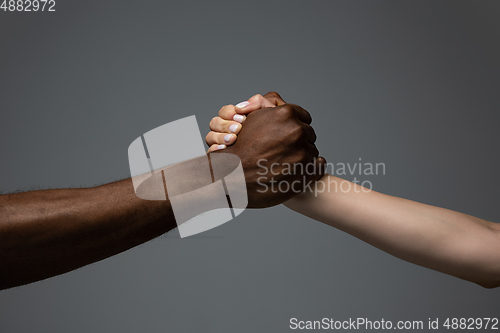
[0,179,176,289]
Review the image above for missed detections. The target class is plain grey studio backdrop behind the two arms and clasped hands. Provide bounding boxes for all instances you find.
[0,0,500,333]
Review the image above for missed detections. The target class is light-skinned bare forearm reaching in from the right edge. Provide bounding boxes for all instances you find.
[285,175,500,288]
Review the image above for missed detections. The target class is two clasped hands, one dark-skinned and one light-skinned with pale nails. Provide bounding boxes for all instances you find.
[206,92,326,208]
